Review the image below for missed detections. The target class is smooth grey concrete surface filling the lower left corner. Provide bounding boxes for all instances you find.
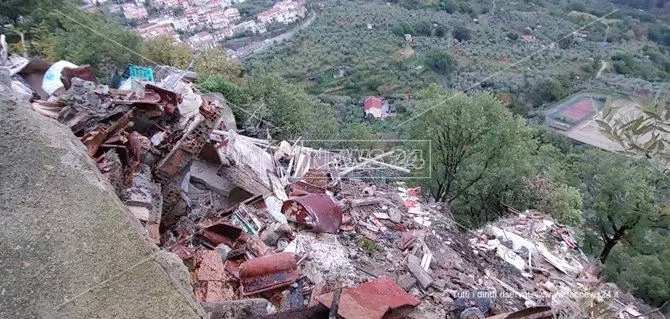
[0,97,204,319]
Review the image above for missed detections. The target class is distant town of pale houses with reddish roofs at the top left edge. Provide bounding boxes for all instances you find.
[84,0,307,50]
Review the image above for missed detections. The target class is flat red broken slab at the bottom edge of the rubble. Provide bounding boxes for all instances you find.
[316,277,421,319]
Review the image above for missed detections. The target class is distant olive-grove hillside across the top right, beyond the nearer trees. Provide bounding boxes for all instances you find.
[259,0,670,115]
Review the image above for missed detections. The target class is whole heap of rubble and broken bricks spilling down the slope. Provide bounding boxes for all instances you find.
[0,50,660,319]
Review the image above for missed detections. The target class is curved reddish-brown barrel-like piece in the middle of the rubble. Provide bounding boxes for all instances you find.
[282,194,342,234]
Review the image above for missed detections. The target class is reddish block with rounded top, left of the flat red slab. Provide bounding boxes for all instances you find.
[240,253,300,296]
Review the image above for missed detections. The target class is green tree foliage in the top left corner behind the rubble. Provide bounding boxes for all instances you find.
[0,0,146,82]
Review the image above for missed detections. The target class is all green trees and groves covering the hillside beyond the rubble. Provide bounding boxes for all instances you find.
[0,0,670,312]
